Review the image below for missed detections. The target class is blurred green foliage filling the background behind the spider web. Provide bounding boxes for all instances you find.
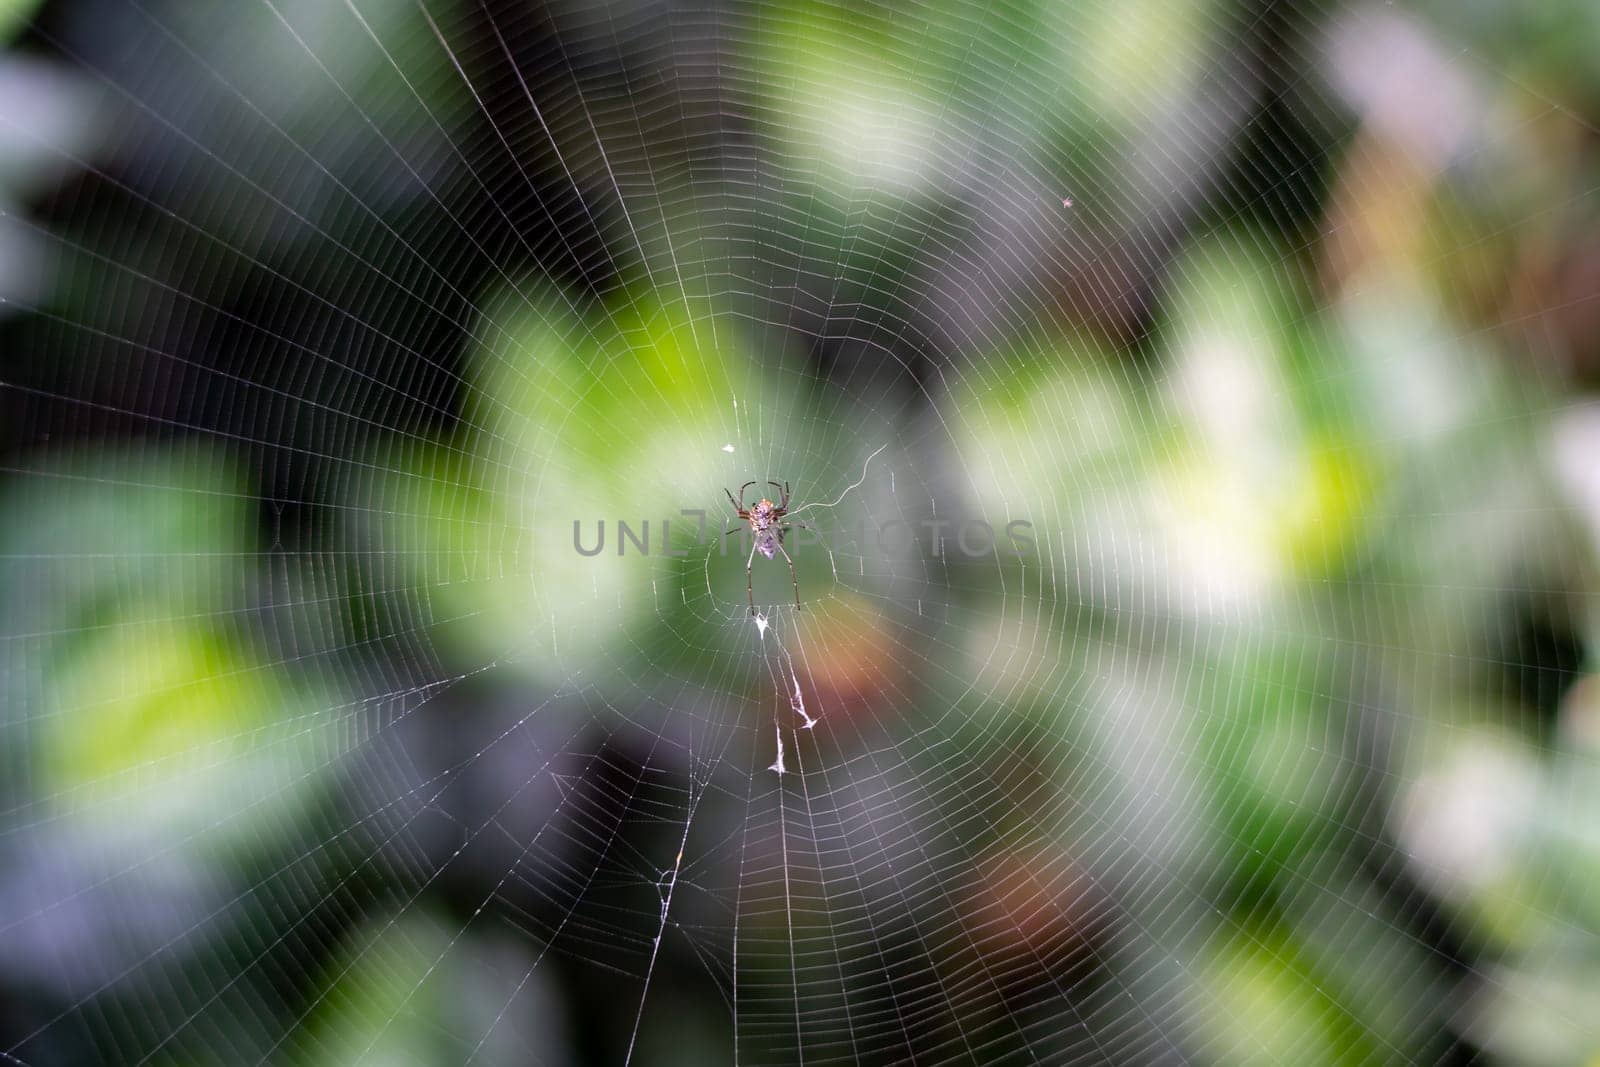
[0,0,1600,1064]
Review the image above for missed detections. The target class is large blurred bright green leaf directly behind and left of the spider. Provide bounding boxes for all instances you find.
[370,290,822,672]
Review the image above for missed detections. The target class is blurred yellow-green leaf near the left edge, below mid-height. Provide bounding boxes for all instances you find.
[37,621,330,851]
